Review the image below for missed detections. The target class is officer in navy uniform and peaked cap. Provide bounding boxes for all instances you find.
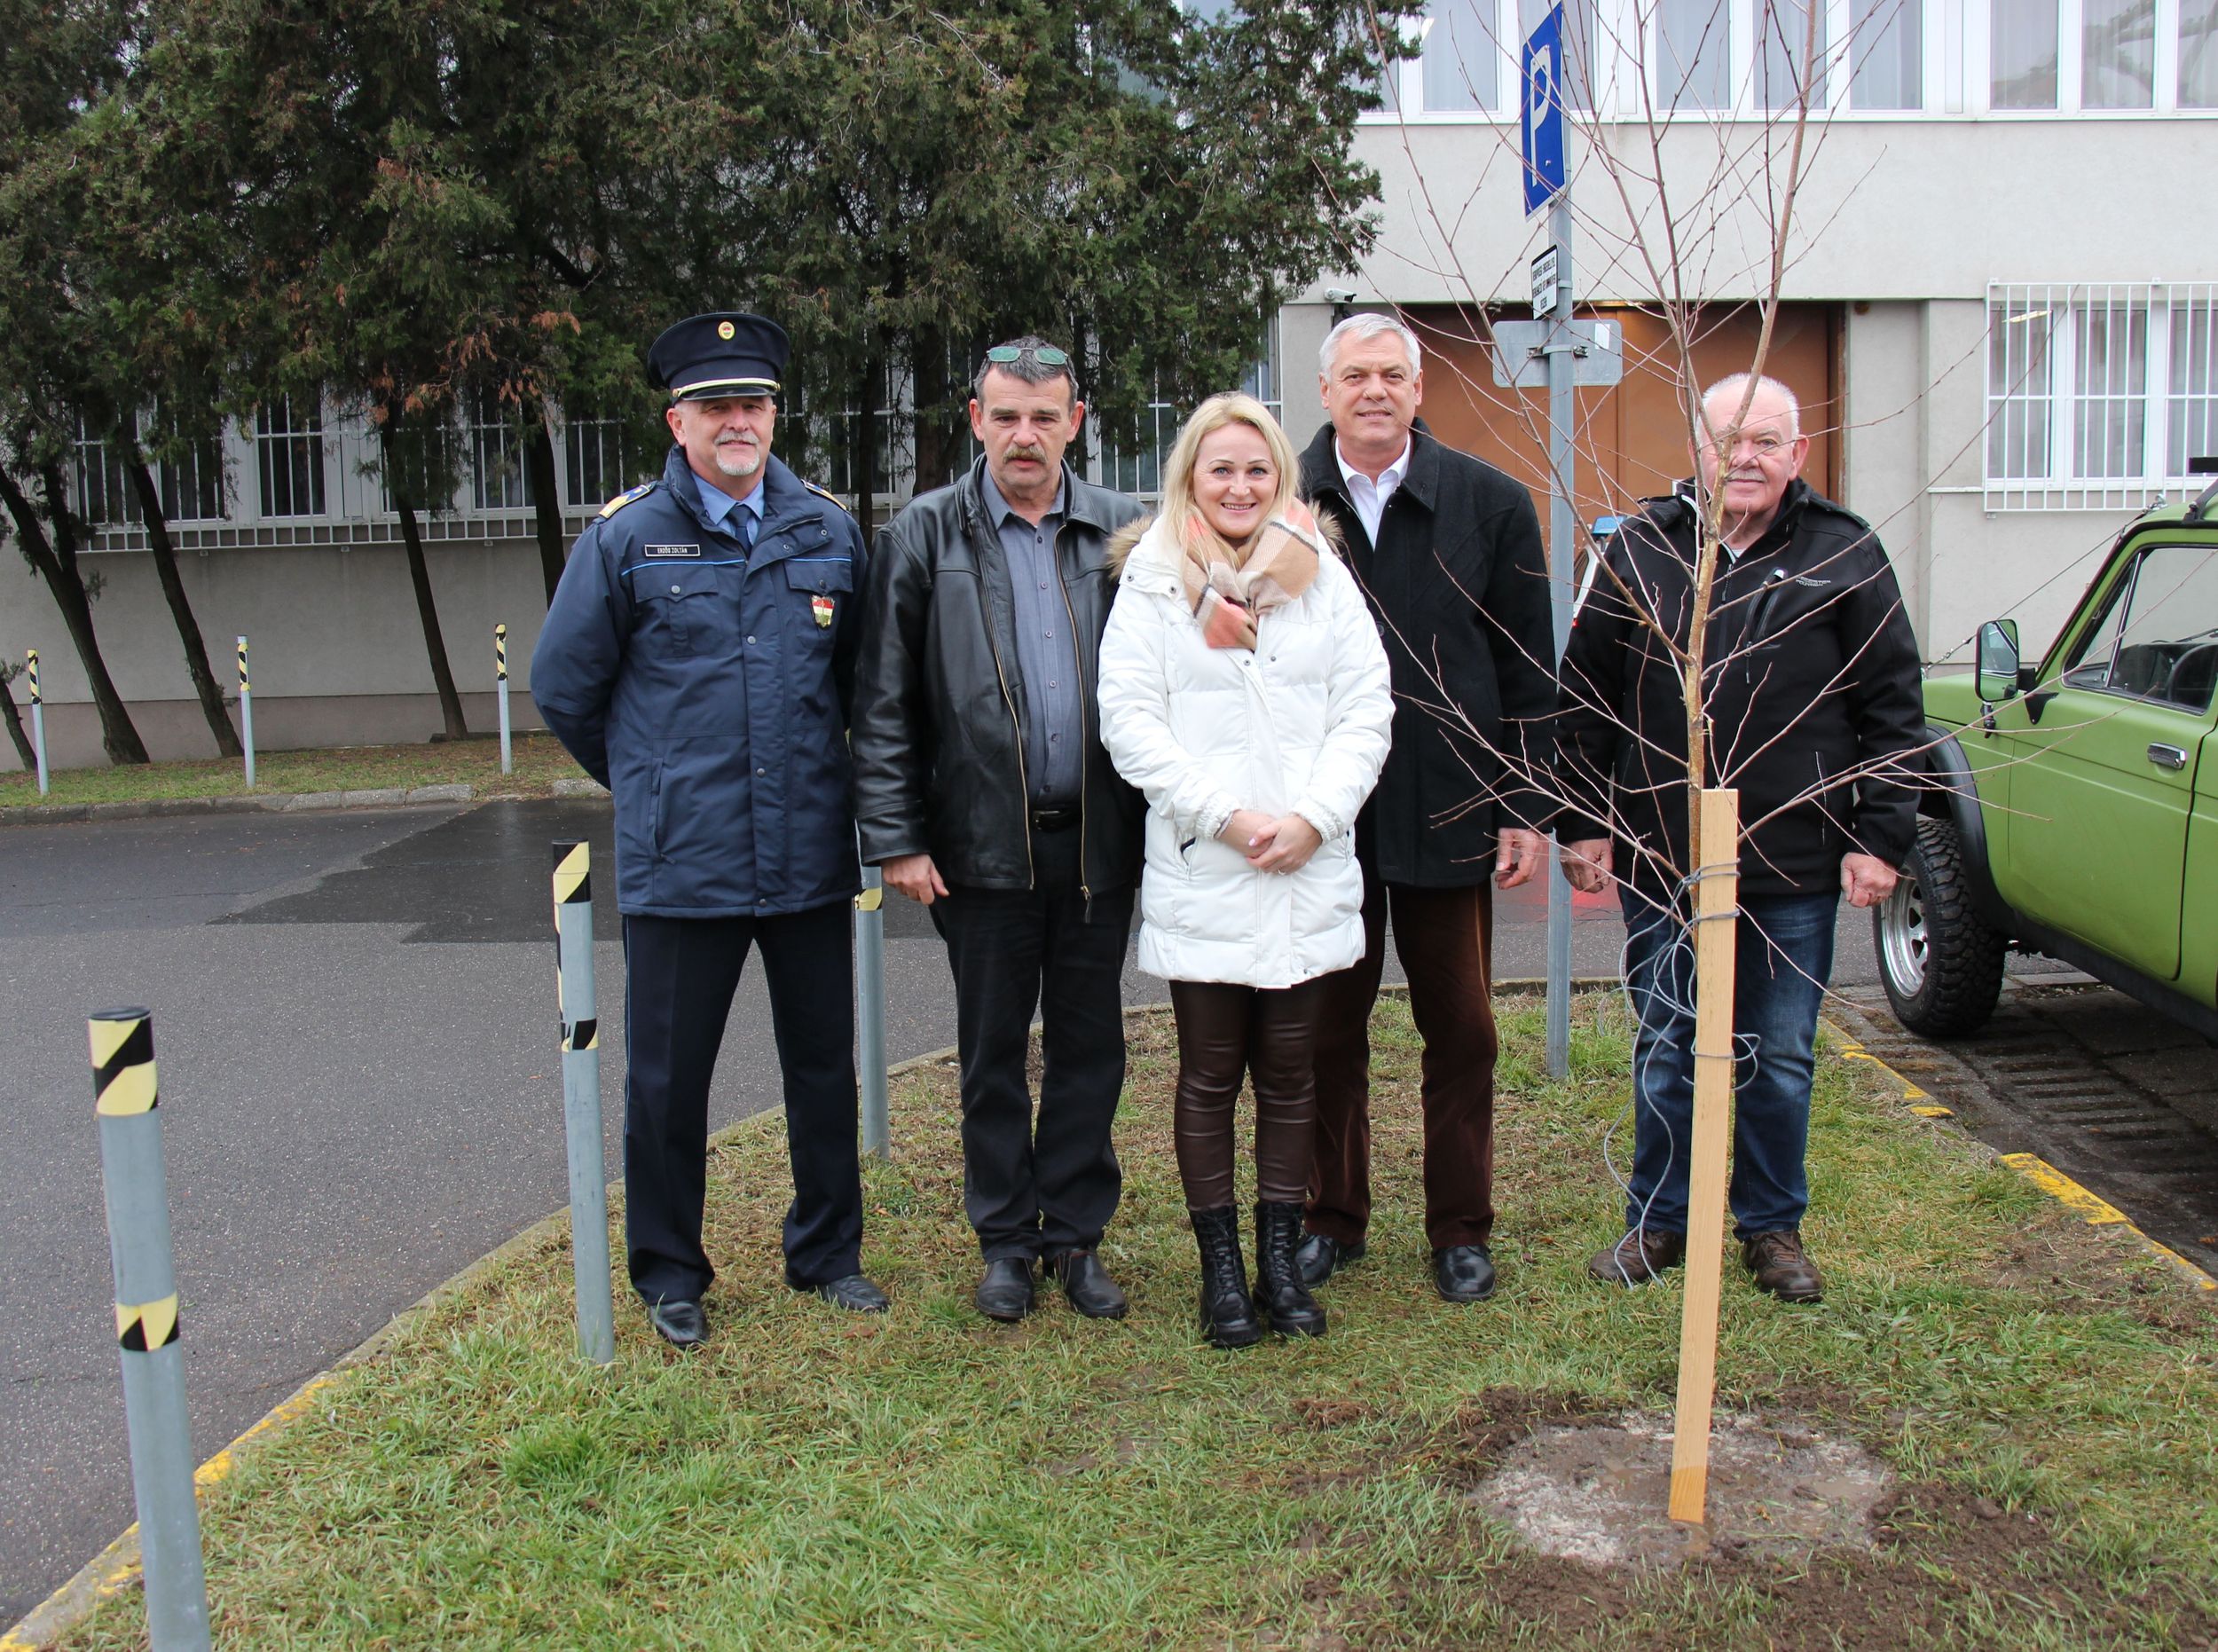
[532,315,885,1349]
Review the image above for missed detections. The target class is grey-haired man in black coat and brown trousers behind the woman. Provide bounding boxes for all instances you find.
[1300,315,1555,1302]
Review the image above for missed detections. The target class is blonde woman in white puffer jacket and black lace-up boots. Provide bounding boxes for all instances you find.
[1100,395,1393,1349]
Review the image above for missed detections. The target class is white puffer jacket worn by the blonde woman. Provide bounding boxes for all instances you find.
[1100,519,1393,987]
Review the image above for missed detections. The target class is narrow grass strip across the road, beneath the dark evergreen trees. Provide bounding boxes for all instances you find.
[0,734,584,807]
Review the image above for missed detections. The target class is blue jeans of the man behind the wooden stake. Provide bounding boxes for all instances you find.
[1619,889,1839,1239]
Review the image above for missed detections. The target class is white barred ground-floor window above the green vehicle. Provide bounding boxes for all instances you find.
[1981,281,2218,510]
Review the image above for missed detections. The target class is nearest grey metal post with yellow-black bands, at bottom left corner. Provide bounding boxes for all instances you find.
[89,1009,208,1652]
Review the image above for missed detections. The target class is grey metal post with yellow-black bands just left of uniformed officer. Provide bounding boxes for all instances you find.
[554,843,617,1366]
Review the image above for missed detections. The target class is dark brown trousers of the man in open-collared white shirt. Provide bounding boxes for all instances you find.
[1309,867,1495,1251]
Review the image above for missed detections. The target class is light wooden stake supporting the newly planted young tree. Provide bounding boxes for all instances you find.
[1671,790,1742,1523]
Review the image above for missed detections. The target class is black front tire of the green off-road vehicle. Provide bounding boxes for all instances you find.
[1872,816,2010,1038]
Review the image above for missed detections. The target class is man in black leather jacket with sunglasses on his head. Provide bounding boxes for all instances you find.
[852,337,1143,1319]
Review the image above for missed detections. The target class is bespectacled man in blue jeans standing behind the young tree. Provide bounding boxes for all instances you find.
[1557,373,1923,1302]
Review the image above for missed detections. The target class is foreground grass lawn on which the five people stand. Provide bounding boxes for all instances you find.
[65,995,2218,1648]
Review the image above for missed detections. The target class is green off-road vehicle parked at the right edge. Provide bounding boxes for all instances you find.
[1872,459,2218,1040]
